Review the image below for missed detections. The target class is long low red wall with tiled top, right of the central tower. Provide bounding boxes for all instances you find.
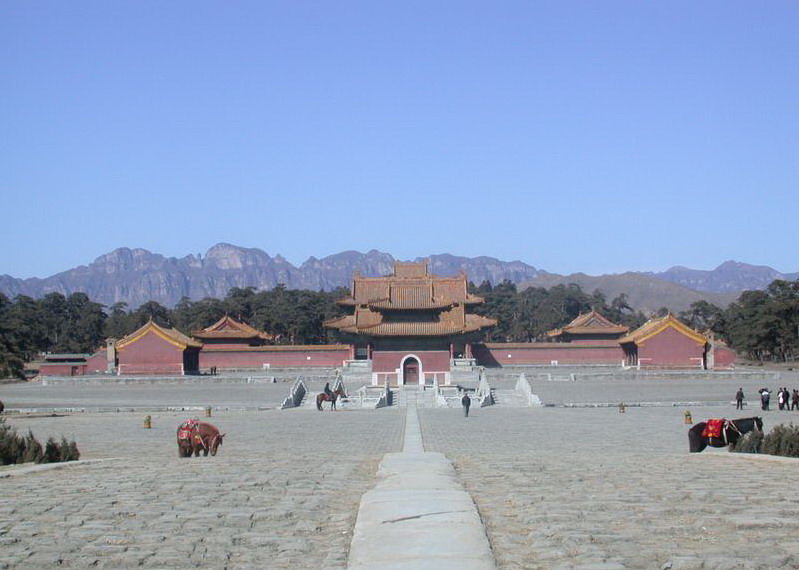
[473,341,624,366]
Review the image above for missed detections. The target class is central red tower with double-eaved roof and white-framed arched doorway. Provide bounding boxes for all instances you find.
[325,261,497,386]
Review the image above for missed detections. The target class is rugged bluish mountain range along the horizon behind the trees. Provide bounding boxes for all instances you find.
[0,243,799,312]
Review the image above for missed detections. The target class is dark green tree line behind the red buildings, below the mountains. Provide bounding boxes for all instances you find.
[0,280,799,377]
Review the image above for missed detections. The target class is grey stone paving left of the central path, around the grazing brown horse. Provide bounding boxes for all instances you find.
[0,410,404,569]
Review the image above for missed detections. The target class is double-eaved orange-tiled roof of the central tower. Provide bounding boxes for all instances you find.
[325,261,496,337]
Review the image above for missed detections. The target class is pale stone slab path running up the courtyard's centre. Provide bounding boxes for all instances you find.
[348,400,496,570]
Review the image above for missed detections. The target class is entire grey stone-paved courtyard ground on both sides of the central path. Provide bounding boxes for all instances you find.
[0,370,799,570]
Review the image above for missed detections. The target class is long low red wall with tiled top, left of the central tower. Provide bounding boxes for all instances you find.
[200,345,350,370]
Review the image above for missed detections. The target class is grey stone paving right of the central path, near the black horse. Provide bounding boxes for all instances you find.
[419,406,799,570]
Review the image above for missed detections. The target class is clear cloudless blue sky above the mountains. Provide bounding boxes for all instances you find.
[0,1,799,277]
